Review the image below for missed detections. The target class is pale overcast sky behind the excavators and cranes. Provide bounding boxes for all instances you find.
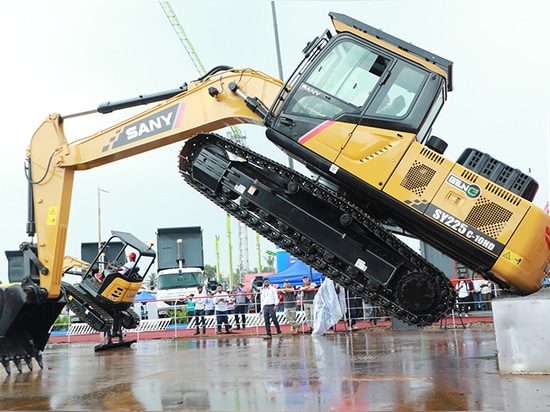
[0,0,550,281]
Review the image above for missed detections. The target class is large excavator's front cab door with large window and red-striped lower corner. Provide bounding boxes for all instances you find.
[275,35,392,163]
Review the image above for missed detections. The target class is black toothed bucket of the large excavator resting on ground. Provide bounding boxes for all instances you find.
[0,284,65,373]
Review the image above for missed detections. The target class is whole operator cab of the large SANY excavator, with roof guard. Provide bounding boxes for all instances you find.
[265,13,452,185]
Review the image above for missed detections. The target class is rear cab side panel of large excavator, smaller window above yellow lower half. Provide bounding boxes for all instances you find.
[334,60,442,189]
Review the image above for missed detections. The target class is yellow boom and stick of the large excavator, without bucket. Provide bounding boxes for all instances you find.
[27,69,281,299]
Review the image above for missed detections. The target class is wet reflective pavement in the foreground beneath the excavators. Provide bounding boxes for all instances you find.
[0,327,550,411]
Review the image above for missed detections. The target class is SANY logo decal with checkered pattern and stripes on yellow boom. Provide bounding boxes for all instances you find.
[103,103,185,152]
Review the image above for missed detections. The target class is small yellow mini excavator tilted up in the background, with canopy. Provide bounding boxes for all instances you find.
[64,231,156,351]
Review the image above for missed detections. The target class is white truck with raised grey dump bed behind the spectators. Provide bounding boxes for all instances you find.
[157,226,207,317]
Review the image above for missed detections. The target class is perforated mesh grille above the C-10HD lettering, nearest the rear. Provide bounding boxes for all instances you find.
[464,196,513,239]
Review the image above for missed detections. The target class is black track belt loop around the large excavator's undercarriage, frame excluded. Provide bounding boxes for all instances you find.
[179,133,455,326]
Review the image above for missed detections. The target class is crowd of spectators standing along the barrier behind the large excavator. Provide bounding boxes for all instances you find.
[146,276,495,339]
